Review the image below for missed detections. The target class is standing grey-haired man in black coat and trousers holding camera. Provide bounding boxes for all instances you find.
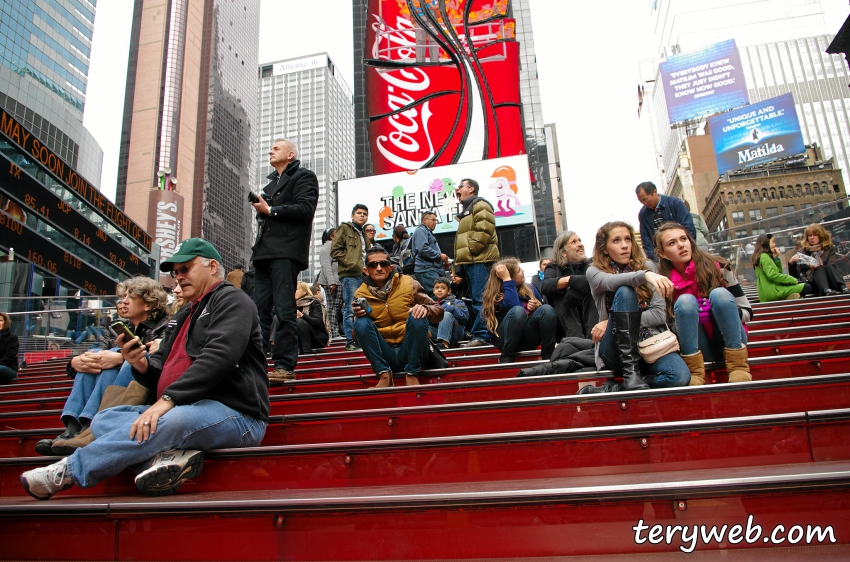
[248,139,319,382]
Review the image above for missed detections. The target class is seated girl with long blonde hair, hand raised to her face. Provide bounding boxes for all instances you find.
[481,258,558,363]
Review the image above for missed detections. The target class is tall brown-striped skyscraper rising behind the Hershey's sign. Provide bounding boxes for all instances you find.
[116,0,260,269]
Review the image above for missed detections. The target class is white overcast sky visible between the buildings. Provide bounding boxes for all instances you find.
[85,0,848,248]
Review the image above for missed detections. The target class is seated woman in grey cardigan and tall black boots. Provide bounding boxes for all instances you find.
[579,221,691,394]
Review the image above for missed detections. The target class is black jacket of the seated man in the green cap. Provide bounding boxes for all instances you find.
[133,281,269,422]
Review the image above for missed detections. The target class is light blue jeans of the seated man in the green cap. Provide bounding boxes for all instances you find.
[68,400,267,488]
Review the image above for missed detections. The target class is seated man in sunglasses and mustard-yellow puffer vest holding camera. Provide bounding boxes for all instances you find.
[353,245,443,388]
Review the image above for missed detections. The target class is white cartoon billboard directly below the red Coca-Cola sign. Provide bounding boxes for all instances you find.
[337,156,534,237]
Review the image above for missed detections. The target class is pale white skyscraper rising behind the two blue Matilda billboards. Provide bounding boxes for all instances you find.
[639,0,850,207]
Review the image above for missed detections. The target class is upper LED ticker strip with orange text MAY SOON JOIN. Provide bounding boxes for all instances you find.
[0,108,151,250]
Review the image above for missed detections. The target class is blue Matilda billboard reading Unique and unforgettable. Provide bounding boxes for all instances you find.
[708,94,806,174]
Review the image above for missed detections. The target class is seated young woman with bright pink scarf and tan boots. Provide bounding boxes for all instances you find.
[654,222,753,386]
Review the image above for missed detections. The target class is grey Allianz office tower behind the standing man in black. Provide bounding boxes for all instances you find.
[254,53,354,281]
